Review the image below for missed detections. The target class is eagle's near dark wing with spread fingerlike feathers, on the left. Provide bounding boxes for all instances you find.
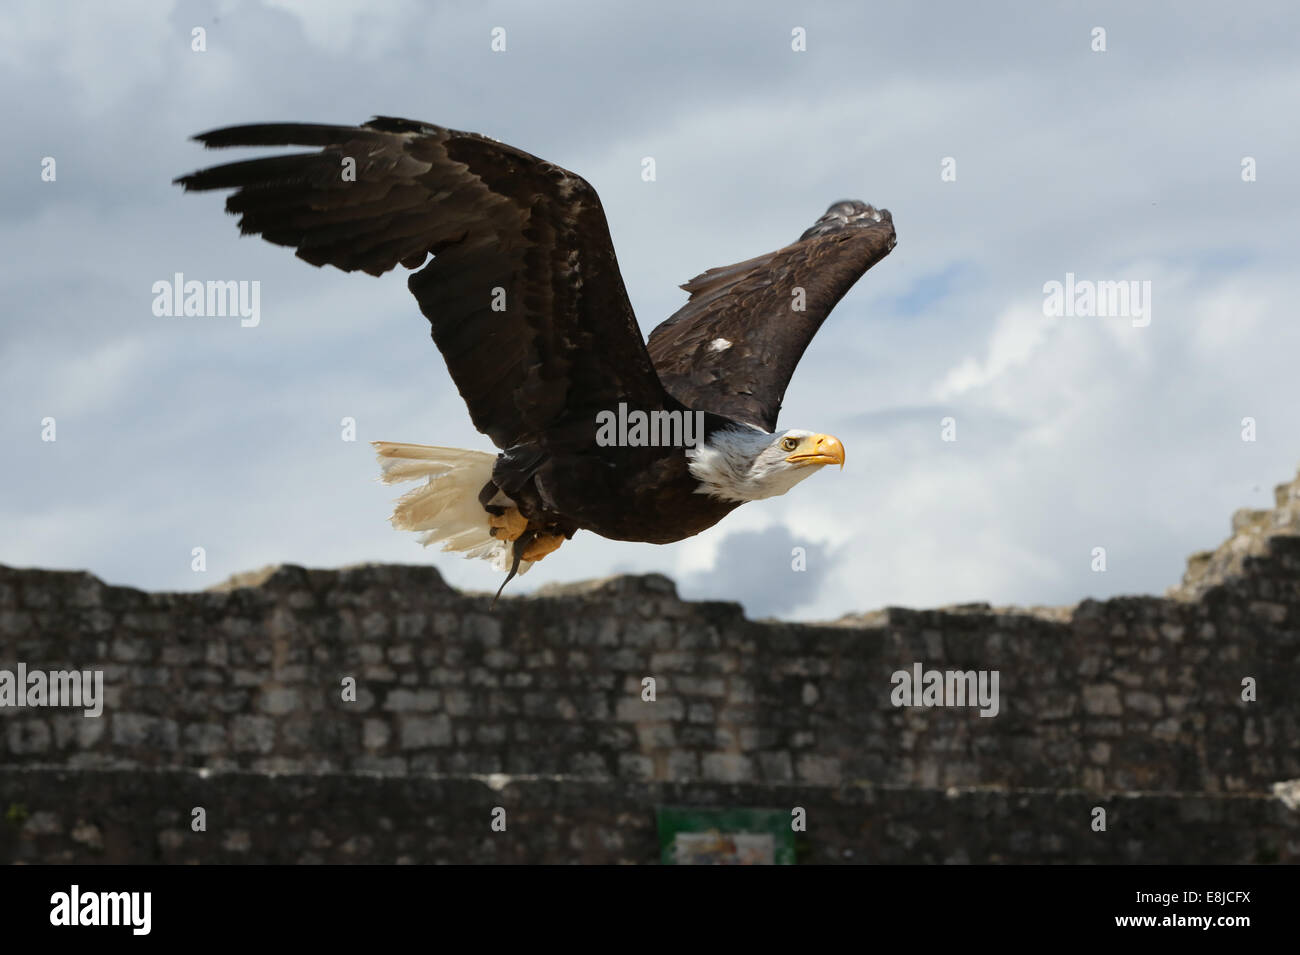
[177,117,670,448]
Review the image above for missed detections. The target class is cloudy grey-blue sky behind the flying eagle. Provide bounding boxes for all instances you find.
[0,0,1300,618]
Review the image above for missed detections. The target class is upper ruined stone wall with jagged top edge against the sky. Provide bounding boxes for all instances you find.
[0,465,1300,860]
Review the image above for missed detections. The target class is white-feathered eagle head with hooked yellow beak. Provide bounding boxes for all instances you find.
[686,427,844,502]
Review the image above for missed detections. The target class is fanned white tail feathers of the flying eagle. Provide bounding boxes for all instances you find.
[372,440,533,573]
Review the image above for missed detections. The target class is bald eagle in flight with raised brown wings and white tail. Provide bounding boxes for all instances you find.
[176,117,894,594]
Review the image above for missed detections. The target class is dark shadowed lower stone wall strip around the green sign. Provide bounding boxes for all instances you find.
[0,769,1300,864]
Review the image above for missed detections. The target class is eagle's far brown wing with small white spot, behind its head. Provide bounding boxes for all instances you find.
[650,200,894,431]
